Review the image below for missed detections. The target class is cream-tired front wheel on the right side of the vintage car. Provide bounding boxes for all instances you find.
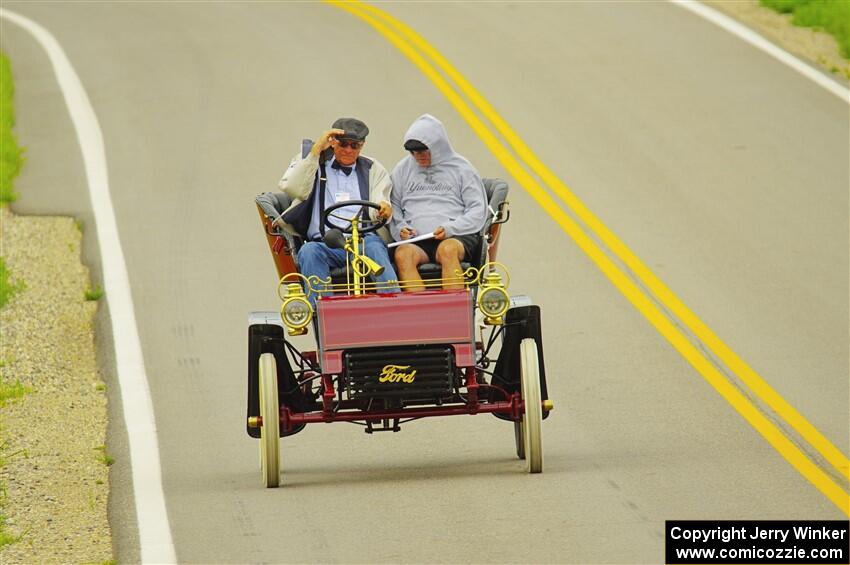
[517,338,543,473]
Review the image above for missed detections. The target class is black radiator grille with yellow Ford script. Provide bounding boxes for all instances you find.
[343,346,455,399]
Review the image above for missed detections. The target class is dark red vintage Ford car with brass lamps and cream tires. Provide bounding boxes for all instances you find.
[246,175,553,487]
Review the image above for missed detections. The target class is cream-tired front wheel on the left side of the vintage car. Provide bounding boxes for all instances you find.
[260,353,280,488]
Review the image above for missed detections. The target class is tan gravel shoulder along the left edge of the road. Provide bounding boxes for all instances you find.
[0,207,113,564]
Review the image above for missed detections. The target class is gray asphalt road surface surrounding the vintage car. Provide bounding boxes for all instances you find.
[2,1,850,563]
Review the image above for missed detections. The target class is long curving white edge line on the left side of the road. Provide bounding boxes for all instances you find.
[0,8,177,563]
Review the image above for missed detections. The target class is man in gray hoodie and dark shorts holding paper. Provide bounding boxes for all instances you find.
[390,114,487,291]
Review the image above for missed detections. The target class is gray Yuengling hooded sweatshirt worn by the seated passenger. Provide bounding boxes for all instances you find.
[390,114,487,240]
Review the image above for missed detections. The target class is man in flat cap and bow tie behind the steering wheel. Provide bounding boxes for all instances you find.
[278,118,398,309]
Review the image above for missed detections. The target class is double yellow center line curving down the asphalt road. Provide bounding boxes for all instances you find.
[327,0,850,516]
